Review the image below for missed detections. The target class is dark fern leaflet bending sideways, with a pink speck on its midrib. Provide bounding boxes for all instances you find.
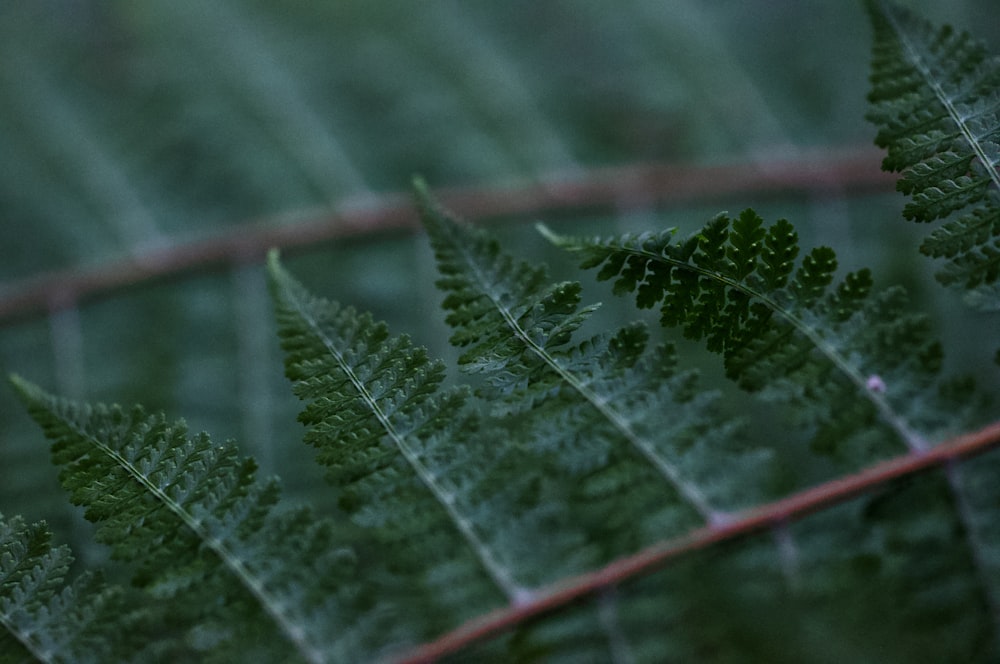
[541,209,976,463]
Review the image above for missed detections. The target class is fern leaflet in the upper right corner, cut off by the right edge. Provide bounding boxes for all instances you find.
[868,0,1000,309]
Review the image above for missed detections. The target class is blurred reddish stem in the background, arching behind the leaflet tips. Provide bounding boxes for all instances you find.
[0,148,896,322]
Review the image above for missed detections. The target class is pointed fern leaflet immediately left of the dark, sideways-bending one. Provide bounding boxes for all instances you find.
[417,183,772,533]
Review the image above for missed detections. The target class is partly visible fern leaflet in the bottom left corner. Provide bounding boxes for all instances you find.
[0,514,135,664]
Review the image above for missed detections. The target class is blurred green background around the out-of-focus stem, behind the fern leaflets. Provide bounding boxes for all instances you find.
[0,0,1000,558]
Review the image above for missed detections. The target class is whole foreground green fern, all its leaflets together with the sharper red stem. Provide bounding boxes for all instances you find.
[0,1,1000,662]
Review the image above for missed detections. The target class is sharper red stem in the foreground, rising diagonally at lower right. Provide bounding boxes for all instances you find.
[395,421,1000,664]
